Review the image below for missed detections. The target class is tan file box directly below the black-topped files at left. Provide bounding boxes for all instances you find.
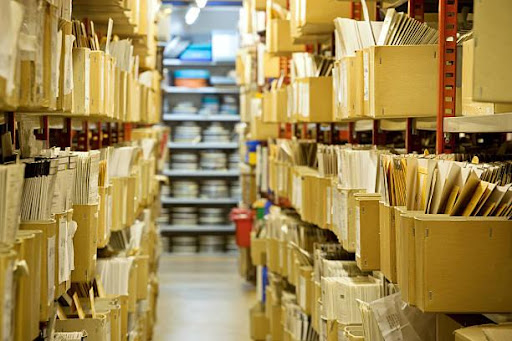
[20,220,57,322]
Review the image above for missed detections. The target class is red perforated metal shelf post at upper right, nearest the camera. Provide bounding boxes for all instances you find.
[436,0,458,154]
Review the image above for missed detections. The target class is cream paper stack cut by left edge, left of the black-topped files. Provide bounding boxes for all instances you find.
[0,164,25,244]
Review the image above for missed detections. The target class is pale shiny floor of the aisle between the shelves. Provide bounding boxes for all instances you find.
[153,253,255,341]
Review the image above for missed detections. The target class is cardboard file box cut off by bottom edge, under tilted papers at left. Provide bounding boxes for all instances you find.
[55,313,110,341]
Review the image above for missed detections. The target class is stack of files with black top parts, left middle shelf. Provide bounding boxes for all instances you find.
[21,158,58,221]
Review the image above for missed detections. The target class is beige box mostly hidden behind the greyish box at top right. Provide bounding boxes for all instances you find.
[462,39,512,116]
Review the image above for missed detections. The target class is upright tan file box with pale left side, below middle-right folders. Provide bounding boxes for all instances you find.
[355,194,380,271]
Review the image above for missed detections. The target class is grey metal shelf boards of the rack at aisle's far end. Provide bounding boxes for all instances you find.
[160,58,240,252]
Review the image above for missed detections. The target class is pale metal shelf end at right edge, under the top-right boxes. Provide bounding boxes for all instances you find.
[444,113,512,133]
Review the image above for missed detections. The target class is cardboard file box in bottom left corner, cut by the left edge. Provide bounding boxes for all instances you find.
[0,245,17,340]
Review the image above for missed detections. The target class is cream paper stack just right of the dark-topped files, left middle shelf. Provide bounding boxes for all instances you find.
[73,150,100,205]
